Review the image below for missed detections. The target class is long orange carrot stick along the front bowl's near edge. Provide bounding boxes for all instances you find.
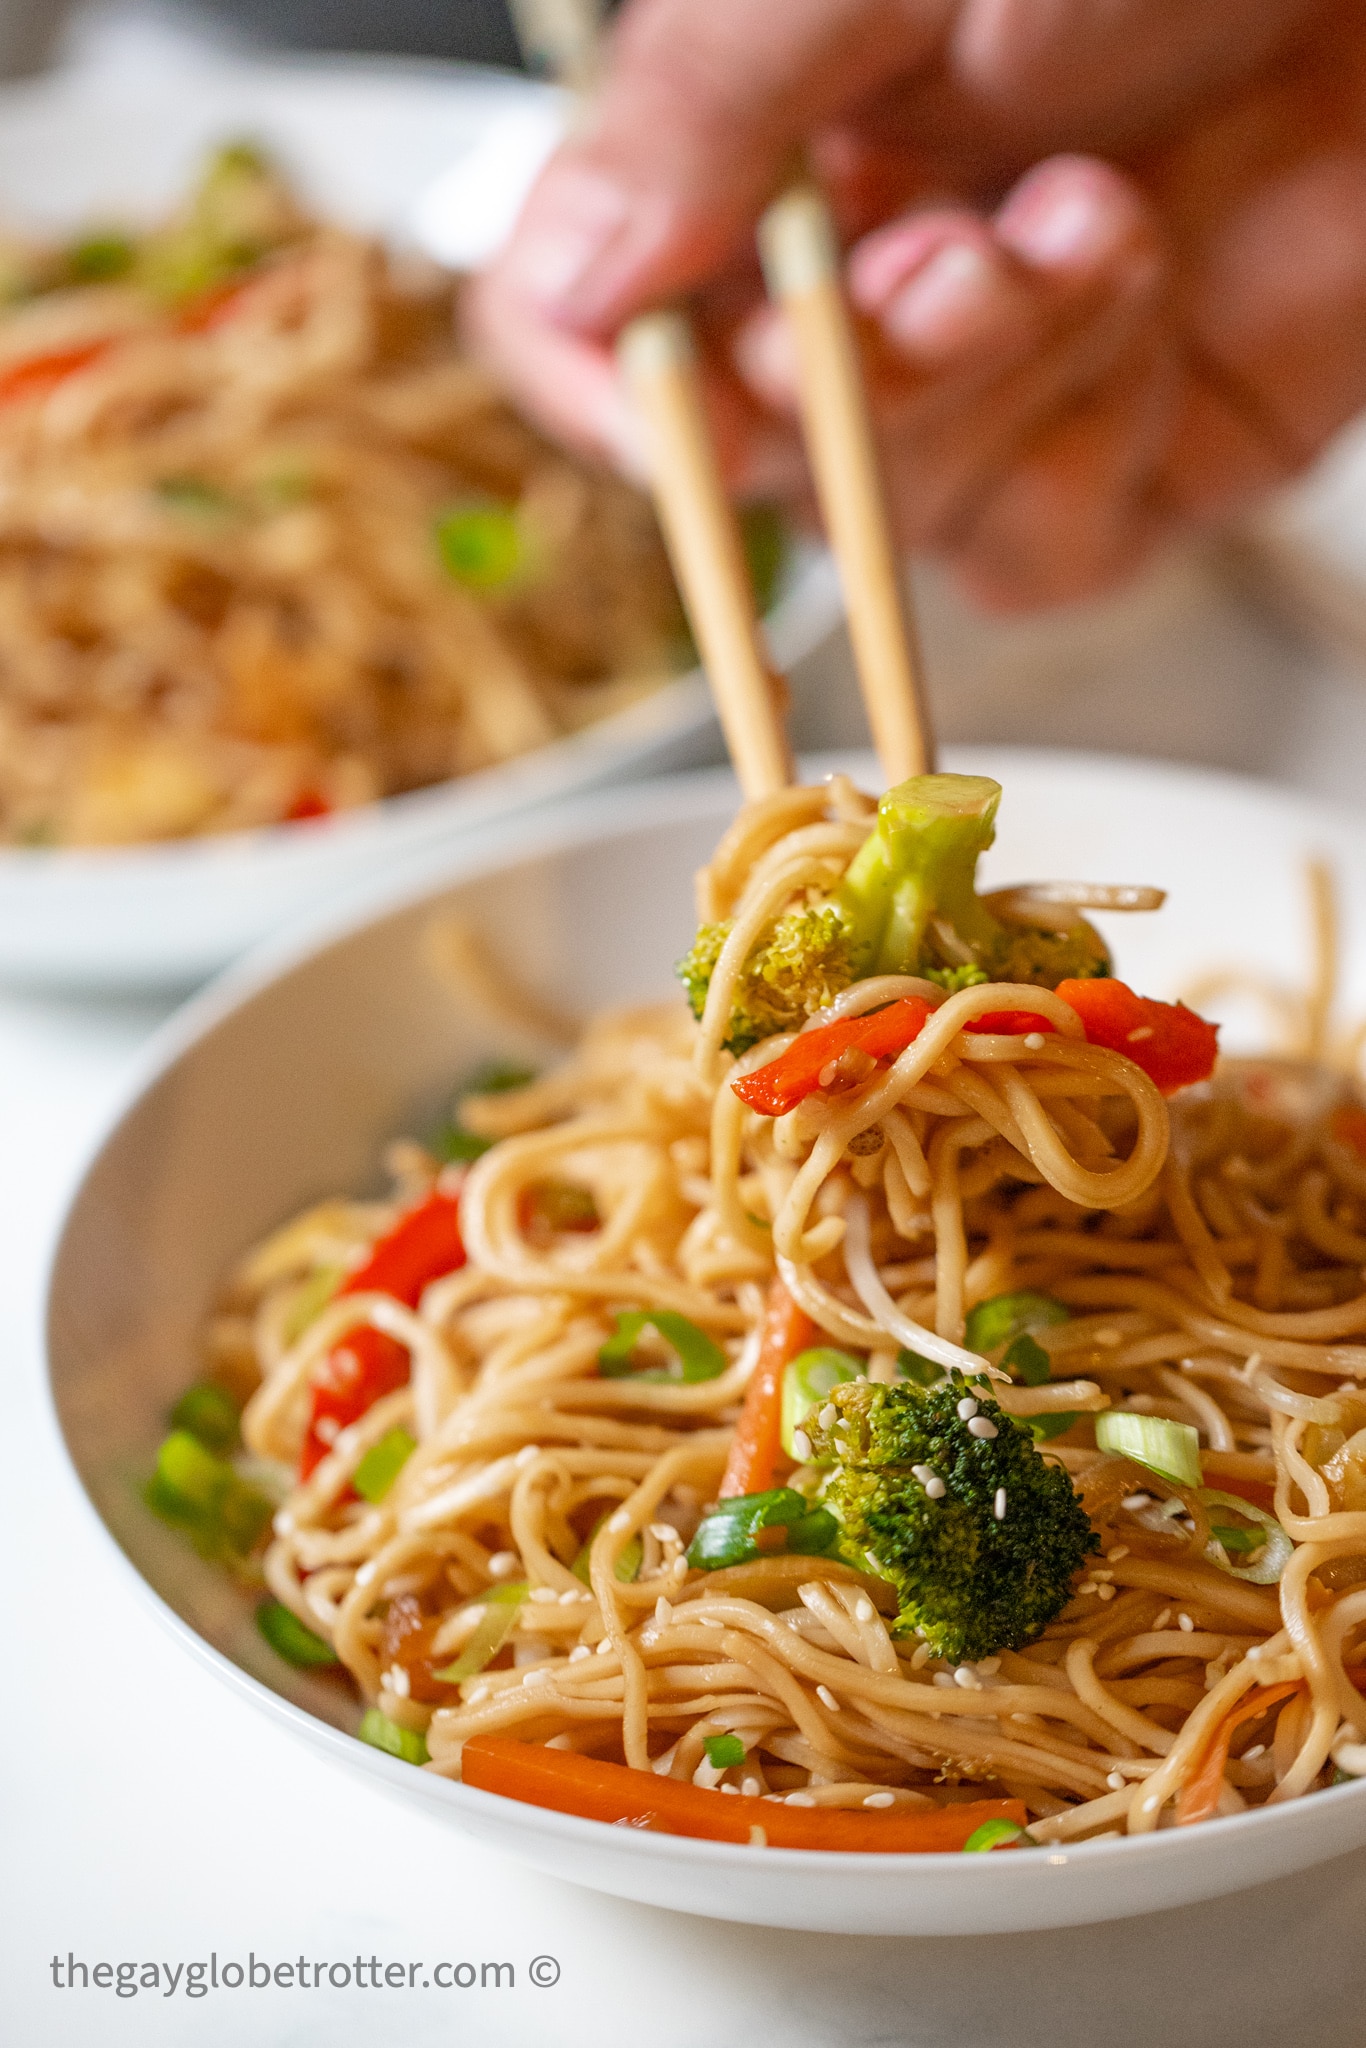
[461,1735,1026,1855]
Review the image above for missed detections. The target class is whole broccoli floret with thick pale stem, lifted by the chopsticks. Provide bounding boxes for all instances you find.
[678,774,1110,1053]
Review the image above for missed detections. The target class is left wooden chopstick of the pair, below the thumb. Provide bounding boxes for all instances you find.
[616,313,793,801]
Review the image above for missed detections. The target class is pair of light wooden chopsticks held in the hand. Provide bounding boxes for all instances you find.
[618,182,934,799]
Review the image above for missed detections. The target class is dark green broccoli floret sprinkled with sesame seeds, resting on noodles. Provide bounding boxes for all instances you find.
[805,1372,1100,1663]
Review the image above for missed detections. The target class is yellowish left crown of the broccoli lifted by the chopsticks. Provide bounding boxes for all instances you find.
[678,899,854,1053]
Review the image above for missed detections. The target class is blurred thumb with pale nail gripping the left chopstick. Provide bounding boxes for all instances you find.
[494,0,952,334]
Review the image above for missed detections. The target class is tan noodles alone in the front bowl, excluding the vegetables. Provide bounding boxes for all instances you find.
[215,782,1366,1841]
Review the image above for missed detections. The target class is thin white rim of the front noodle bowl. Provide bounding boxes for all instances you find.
[43,745,1366,1890]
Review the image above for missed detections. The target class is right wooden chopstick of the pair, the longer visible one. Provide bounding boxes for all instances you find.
[760,182,934,782]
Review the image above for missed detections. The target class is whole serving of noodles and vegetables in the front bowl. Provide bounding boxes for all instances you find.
[147,776,1366,1849]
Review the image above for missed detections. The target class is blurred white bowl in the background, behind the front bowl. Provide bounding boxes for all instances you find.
[0,61,840,989]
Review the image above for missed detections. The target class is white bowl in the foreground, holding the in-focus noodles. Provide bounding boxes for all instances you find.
[49,750,1366,1933]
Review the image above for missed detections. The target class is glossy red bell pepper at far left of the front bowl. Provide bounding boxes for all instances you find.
[299,1192,465,1479]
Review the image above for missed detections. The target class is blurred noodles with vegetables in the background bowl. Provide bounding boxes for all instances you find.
[0,143,724,846]
